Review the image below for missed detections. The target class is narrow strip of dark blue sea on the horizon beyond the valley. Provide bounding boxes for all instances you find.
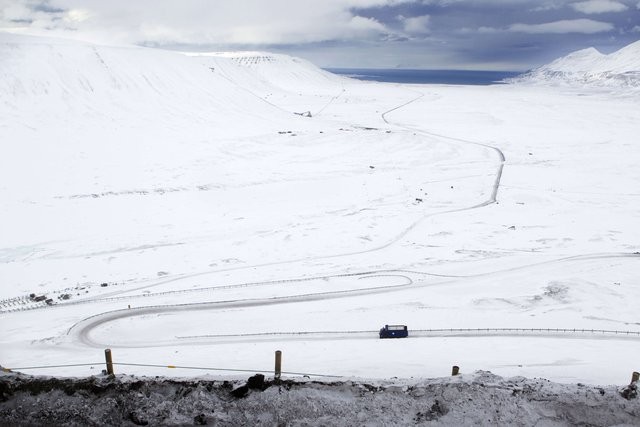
[326,68,522,85]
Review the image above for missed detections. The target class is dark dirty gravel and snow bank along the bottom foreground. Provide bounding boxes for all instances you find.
[0,371,640,426]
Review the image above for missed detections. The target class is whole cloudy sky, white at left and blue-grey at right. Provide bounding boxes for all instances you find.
[0,0,640,71]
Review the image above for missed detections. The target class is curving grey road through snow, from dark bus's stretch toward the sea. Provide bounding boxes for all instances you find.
[61,82,639,362]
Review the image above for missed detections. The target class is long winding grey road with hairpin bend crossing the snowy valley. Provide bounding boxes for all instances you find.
[28,81,640,364]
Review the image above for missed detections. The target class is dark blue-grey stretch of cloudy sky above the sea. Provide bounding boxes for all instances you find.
[344,0,640,69]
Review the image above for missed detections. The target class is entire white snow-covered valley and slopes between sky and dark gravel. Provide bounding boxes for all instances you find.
[0,34,640,384]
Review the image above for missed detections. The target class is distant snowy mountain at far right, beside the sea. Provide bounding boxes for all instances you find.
[514,41,640,87]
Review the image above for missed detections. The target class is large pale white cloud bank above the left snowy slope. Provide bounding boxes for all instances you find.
[0,0,410,45]
